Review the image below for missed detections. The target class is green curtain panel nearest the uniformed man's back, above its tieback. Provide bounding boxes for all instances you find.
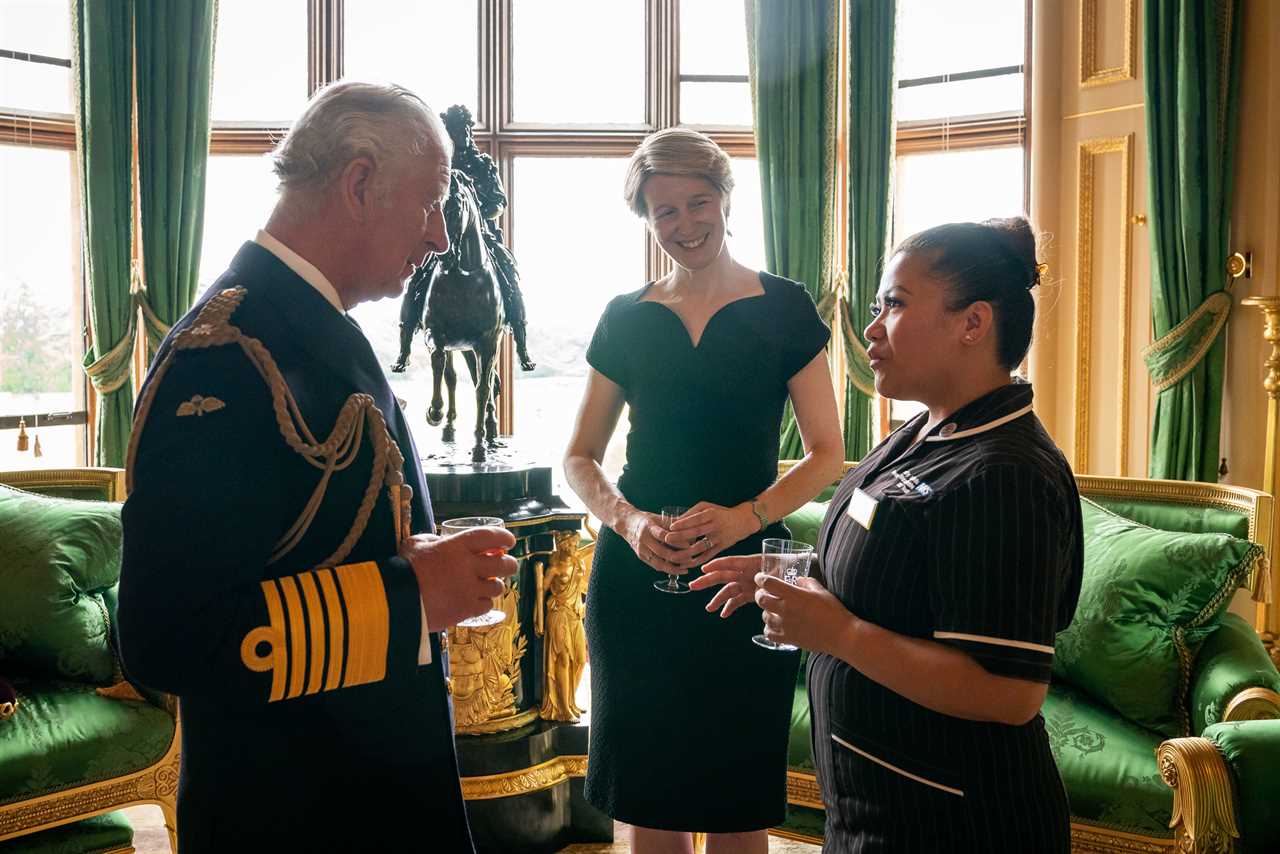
[134,0,214,361]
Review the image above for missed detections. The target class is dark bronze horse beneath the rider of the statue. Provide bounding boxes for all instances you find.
[412,169,506,462]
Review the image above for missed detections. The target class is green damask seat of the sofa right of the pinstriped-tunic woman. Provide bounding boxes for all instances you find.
[1042,682,1172,839]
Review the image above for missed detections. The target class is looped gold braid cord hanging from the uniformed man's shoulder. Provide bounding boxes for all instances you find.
[127,288,413,566]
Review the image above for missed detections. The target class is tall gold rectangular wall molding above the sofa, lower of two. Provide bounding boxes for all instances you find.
[1073,133,1133,475]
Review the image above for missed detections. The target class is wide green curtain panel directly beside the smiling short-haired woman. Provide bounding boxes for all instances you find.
[746,0,837,460]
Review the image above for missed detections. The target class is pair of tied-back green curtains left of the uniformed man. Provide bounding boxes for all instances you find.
[73,0,215,466]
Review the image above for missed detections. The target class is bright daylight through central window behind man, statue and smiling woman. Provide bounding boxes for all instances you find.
[201,0,764,495]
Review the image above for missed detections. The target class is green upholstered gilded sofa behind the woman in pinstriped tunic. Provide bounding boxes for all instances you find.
[777,476,1280,853]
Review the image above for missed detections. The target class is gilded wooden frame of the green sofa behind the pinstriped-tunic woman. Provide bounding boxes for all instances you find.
[773,471,1280,854]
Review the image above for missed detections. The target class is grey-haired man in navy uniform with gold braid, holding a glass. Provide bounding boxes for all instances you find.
[119,83,516,854]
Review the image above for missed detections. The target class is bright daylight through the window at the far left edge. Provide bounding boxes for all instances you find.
[0,0,86,470]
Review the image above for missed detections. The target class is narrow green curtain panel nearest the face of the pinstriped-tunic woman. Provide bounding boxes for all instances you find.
[840,0,897,460]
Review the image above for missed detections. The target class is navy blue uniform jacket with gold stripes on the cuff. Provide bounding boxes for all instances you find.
[119,243,472,854]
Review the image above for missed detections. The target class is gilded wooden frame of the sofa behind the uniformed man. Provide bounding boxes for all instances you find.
[0,467,182,854]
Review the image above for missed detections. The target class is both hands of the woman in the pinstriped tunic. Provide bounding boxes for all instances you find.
[689,554,858,653]
